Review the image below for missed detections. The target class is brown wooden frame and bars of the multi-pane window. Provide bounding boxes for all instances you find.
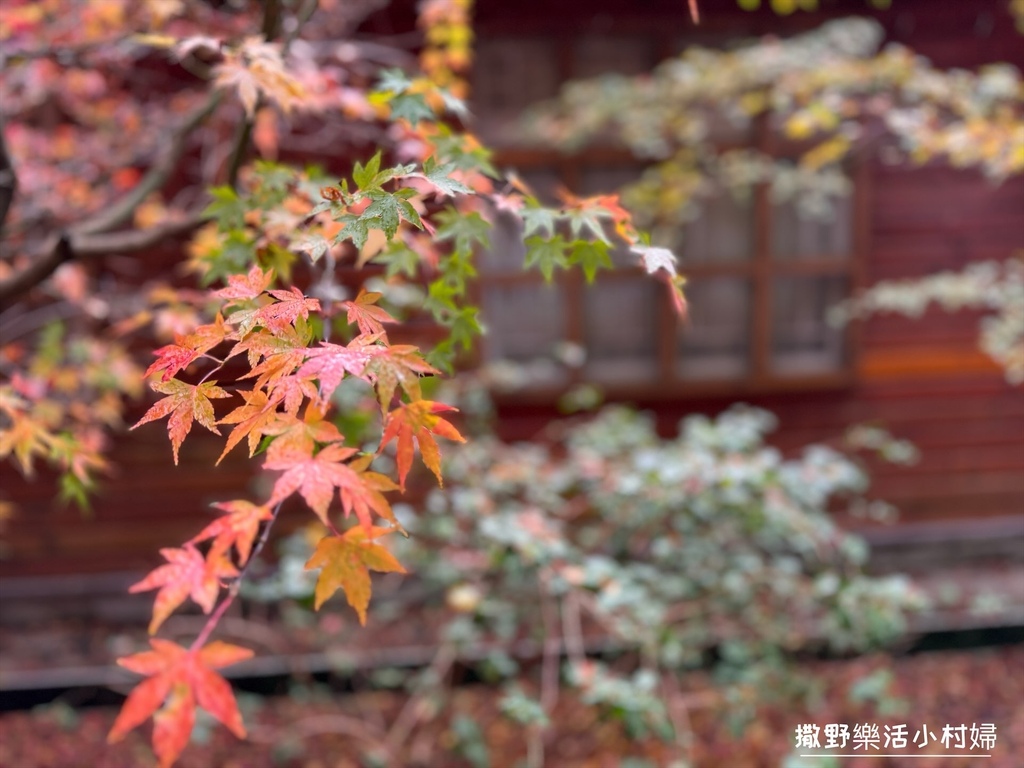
[472,25,869,402]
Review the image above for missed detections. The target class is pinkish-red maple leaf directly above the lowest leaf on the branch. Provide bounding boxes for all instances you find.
[128,544,239,635]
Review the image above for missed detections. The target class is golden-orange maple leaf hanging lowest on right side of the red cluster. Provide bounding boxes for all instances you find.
[306,525,406,626]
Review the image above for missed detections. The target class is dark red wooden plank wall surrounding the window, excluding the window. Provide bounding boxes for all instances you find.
[0,0,1024,578]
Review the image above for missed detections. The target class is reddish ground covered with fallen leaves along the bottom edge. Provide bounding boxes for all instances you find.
[0,645,1024,768]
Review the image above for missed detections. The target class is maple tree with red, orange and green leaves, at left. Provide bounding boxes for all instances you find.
[0,0,1021,766]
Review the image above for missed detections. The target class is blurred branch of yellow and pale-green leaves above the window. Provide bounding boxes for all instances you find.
[531,18,1024,243]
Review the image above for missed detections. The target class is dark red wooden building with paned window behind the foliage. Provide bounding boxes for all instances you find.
[0,0,1024,578]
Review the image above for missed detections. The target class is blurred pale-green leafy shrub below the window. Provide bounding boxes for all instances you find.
[251,399,922,764]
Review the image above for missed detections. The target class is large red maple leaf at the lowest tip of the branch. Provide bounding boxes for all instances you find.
[106,637,253,768]
